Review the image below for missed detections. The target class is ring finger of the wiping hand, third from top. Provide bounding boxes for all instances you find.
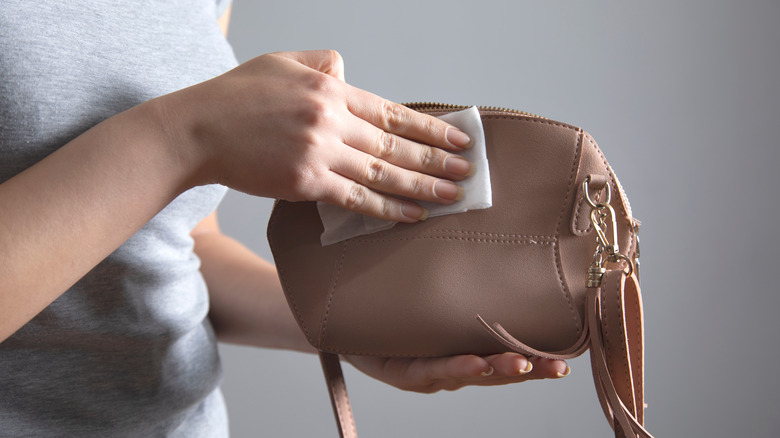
[331,148,463,204]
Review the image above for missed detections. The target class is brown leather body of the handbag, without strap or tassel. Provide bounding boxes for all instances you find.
[268,105,638,357]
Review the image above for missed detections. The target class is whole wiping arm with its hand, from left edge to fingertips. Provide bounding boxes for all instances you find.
[0,47,470,341]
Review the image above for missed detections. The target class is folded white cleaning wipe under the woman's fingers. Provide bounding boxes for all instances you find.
[317,106,493,246]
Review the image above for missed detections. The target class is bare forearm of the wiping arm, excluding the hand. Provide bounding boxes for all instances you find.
[0,100,194,342]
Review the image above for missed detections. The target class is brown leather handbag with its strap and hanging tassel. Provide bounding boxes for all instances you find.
[268,103,650,437]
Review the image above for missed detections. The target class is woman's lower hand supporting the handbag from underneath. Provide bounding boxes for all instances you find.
[345,353,571,393]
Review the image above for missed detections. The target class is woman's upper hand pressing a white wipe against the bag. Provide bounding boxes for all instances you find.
[160,51,471,222]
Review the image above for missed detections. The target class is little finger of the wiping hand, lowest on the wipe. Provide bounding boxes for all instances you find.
[317,172,428,223]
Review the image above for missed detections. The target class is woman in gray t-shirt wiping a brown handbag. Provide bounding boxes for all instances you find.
[0,0,568,437]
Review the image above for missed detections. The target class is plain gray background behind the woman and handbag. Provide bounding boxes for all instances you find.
[215,0,780,437]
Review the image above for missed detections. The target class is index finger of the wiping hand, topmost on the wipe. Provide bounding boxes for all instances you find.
[347,87,471,151]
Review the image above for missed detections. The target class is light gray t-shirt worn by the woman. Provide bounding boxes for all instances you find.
[0,0,236,438]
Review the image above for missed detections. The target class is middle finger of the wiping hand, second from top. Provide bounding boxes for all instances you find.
[344,122,474,180]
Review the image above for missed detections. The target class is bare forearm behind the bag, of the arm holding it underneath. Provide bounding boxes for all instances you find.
[193,217,314,352]
